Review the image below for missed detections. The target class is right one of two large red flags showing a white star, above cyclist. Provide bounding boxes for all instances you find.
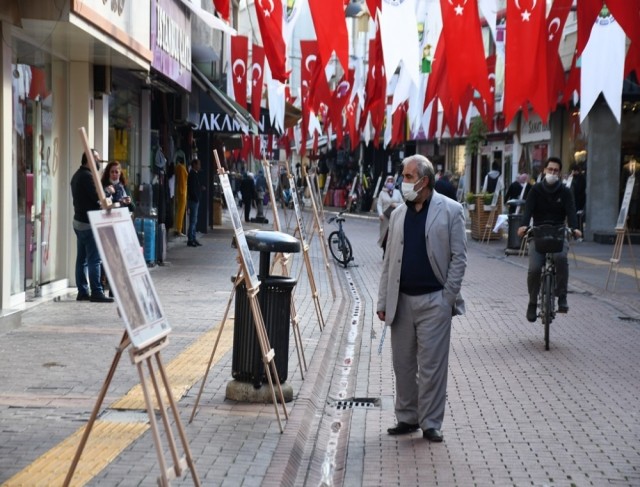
[502,0,550,125]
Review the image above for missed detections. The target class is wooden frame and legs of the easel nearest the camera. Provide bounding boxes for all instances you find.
[62,132,200,487]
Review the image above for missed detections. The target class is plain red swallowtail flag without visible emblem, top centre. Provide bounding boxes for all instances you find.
[309,0,349,71]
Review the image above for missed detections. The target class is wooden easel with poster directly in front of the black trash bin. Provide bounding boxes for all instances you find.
[189,150,289,433]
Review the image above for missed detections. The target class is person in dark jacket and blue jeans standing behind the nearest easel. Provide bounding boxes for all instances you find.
[71,149,113,303]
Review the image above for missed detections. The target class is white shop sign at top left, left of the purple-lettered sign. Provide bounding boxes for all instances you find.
[71,0,152,61]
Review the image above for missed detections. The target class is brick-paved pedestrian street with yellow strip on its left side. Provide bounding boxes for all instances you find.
[0,204,640,486]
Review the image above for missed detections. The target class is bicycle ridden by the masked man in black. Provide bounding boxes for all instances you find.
[526,224,568,350]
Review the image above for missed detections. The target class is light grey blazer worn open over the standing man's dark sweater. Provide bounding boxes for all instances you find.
[377,191,467,325]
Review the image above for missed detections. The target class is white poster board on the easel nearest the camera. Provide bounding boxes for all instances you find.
[88,208,171,349]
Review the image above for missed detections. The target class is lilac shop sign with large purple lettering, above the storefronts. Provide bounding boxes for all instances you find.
[151,0,191,91]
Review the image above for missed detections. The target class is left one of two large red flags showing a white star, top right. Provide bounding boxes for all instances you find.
[440,0,490,115]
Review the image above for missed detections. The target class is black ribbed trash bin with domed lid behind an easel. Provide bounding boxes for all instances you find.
[231,230,300,388]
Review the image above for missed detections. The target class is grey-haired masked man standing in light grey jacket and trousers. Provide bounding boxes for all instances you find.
[377,155,467,442]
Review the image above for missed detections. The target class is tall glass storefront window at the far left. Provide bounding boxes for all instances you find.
[11,42,68,295]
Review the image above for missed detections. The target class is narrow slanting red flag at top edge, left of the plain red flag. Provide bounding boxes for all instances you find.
[254,0,289,83]
